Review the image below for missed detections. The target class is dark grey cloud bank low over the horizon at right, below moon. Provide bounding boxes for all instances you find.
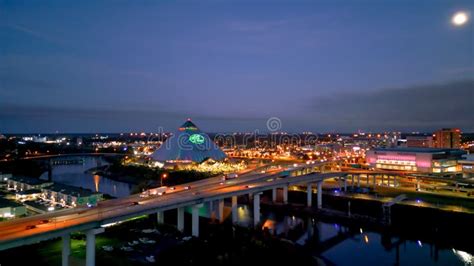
[310,80,474,131]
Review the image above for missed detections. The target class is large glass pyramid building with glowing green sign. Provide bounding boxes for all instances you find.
[151,119,226,163]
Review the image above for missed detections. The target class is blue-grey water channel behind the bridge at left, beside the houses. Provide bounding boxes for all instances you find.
[40,157,133,197]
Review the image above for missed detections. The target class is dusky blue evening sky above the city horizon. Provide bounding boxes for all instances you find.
[0,0,474,133]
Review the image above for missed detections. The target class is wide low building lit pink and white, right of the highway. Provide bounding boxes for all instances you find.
[366,148,464,173]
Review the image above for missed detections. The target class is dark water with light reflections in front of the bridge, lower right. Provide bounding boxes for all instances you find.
[238,206,474,265]
